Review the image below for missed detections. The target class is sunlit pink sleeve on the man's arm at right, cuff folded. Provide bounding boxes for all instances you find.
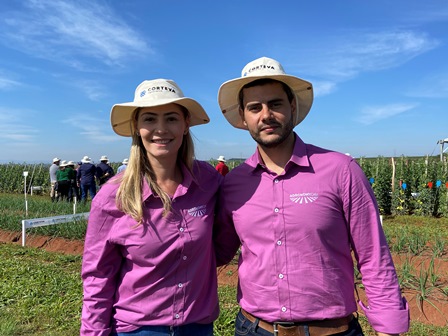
[343,161,410,334]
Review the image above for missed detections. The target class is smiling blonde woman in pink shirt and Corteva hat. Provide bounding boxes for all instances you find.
[81,79,221,336]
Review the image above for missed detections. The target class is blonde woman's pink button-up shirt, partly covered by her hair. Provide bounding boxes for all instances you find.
[81,161,222,335]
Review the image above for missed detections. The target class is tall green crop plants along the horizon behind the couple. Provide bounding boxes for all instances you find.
[0,157,448,217]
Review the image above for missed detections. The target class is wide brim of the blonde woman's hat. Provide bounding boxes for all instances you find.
[110,97,210,137]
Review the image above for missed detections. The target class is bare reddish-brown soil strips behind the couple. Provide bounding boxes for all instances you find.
[0,230,448,327]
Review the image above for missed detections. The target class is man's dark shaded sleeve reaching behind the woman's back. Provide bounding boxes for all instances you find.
[213,184,240,267]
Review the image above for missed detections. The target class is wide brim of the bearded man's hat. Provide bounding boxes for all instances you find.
[218,75,313,130]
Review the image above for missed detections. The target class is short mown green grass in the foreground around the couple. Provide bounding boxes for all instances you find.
[0,244,448,336]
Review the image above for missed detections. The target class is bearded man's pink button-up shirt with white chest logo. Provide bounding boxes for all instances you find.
[215,135,409,333]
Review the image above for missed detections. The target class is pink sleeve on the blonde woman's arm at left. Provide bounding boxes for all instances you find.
[80,197,121,336]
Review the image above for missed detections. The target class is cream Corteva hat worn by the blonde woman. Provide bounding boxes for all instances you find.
[110,78,210,136]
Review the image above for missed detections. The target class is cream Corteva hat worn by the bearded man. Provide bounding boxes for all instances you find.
[218,57,313,130]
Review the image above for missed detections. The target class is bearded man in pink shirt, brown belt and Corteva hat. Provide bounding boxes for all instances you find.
[214,57,409,336]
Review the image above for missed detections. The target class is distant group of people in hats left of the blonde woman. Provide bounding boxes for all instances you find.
[49,155,128,202]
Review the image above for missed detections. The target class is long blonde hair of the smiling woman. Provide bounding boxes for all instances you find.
[116,105,194,224]
